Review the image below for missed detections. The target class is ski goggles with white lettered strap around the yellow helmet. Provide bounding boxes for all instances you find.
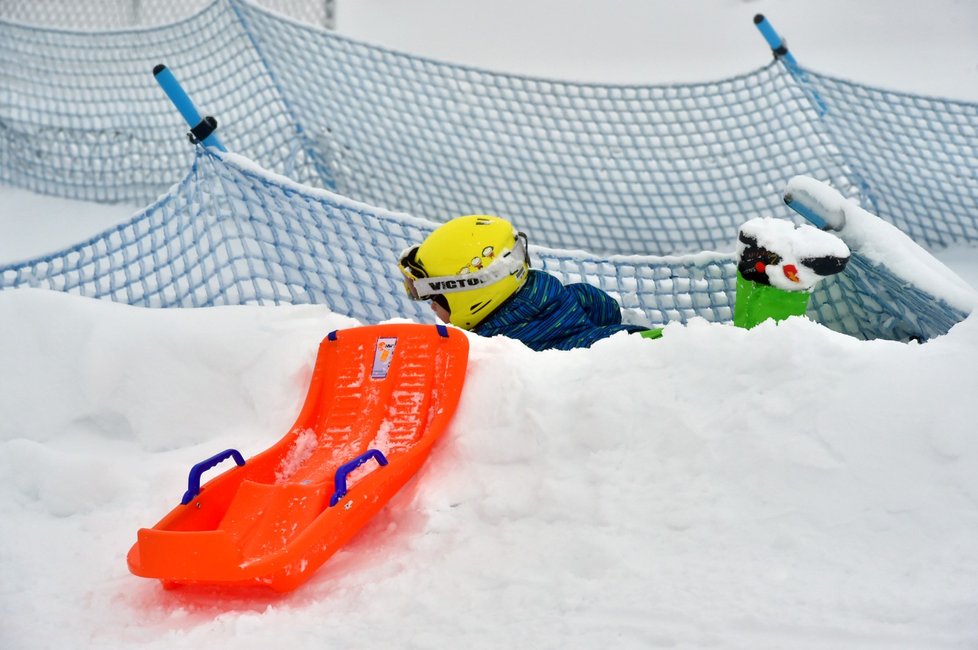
[399,233,530,300]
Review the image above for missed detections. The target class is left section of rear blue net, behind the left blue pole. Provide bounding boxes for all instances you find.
[0,1,317,205]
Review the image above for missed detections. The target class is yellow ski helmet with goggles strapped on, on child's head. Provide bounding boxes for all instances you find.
[400,214,530,330]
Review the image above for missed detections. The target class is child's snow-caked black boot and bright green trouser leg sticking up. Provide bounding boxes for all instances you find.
[734,217,850,329]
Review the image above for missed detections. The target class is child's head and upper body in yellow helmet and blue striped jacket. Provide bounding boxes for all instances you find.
[392,215,660,350]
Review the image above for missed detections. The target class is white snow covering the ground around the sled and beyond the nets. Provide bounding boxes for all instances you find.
[0,0,978,649]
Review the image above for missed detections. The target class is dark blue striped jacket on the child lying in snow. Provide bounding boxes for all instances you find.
[472,269,646,350]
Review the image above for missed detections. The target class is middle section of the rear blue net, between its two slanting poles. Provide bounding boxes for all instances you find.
[238,3,852,254]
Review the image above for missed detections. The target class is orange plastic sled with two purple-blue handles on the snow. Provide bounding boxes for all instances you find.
[128,324,468,591]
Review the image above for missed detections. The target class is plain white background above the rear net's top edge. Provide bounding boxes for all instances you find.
[337,0,978,101]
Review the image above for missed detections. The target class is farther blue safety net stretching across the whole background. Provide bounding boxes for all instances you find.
[0,0,978,254]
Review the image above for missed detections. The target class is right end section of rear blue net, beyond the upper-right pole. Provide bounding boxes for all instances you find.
[803,72,978,247]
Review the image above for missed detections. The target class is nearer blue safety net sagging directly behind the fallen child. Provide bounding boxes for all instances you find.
[0,147,965,339]
